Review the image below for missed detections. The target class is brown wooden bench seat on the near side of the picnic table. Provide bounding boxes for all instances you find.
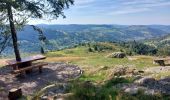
[12,62,48,74]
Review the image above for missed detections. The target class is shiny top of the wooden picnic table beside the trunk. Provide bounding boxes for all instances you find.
[7,55,46,65]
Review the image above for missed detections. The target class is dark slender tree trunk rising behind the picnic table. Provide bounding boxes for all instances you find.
[7,4,21,61]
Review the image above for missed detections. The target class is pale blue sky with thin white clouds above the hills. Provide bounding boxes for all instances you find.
[29,0,170,25]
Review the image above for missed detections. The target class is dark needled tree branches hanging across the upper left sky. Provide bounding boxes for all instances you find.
[0,0,74,18]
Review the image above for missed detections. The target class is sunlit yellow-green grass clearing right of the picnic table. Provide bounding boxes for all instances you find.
[46,46,155,83]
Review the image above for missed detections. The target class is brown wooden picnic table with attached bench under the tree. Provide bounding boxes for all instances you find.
[7,55,47,73]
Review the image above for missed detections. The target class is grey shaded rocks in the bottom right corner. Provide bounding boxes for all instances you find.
[116,77,170,95]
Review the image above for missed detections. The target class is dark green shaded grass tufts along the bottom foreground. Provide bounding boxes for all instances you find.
[67,78,170,100]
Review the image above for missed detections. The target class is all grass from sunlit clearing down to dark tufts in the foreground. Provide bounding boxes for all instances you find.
[44,46,168,100]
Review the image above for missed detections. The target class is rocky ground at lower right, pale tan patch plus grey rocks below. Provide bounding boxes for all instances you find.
[115,66,170,95]
